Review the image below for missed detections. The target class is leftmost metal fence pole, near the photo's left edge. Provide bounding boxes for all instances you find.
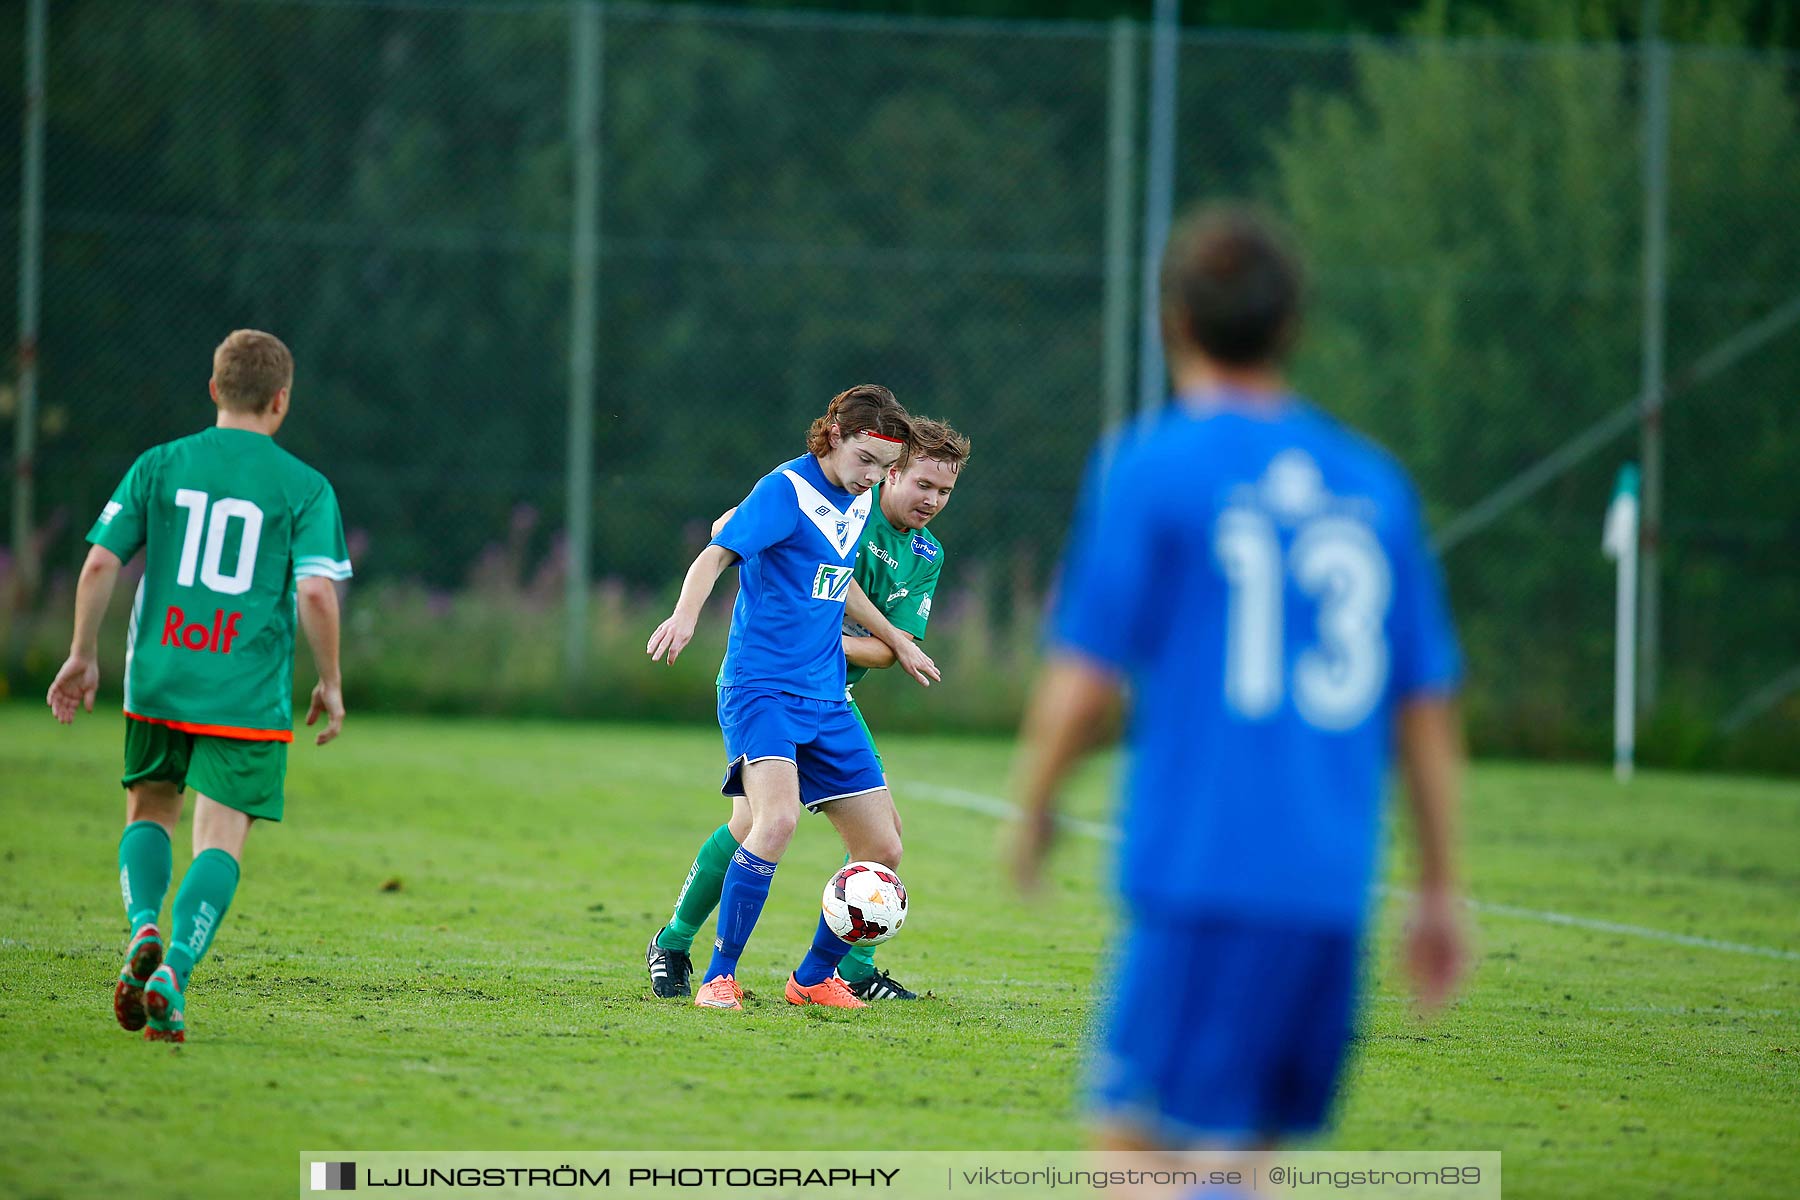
[13,0,49,603]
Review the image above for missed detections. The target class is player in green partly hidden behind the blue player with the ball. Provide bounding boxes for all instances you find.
[644,417,968,1002]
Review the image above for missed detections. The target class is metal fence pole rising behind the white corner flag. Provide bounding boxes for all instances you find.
[1638,0,1669,709]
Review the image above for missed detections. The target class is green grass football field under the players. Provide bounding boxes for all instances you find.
[0,705,1800,1198]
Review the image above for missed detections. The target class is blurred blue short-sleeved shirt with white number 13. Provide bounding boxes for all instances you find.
[1051,398,1462,928]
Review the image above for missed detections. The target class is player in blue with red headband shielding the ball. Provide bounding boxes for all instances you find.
[648,383,913,1009]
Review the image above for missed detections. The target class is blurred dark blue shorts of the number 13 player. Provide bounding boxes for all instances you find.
[1089,912,1361,1146]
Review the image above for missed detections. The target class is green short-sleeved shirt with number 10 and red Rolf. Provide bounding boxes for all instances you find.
[88,428,351,741]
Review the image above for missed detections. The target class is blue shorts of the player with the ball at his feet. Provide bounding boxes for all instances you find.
[718,687,887,811]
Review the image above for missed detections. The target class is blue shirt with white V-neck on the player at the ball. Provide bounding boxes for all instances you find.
[713,453,871,700]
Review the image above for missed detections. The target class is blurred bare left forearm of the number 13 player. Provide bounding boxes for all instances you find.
[1013,655,1121,892]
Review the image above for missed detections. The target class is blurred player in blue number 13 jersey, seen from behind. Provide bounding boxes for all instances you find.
[1017,209,1463,1150]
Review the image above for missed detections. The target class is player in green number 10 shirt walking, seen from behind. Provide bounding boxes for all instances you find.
[49,329,349,1042]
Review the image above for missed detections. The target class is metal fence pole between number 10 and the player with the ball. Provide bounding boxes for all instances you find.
[563,0,601,680]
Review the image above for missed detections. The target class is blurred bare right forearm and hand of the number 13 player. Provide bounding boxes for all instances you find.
[1397,696,1469,1013]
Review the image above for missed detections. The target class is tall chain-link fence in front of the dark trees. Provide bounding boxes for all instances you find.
[0,0,1800,770]
